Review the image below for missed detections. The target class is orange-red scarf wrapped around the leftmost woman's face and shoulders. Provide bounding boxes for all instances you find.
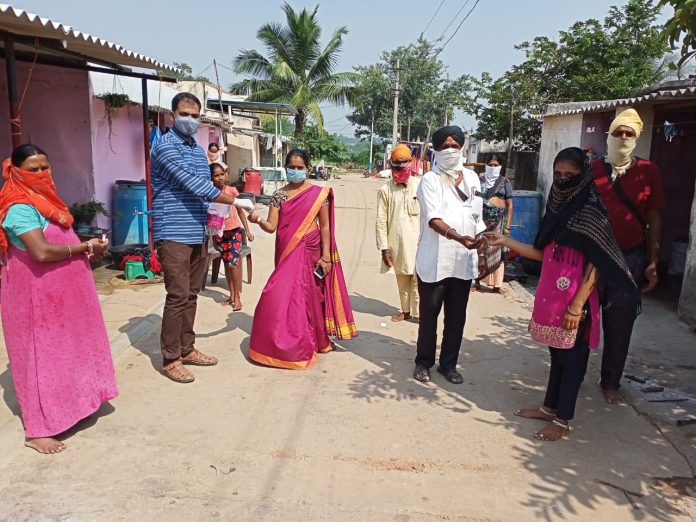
[0,158,73,252]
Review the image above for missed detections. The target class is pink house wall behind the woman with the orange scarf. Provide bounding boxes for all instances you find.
[0,59,94,205]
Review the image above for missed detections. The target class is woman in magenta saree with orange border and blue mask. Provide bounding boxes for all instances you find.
[249,149,357,370]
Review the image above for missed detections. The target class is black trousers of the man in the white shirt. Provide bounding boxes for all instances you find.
[416,277,471,370]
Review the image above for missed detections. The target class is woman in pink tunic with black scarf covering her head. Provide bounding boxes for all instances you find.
[487,147,638,441]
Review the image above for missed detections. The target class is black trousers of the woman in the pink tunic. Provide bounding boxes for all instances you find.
[544,319,590,420]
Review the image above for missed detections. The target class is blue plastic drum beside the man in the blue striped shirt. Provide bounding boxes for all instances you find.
[112,180,149,246]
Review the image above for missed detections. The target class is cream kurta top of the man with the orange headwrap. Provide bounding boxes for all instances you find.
[375,177,420,275]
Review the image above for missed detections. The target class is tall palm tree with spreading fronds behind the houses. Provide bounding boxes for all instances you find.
[230,3,359,136]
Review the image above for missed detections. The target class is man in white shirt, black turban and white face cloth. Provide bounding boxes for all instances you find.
[413,126,486,384]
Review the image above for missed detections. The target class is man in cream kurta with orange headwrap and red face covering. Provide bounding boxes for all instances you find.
[375,144,420,321]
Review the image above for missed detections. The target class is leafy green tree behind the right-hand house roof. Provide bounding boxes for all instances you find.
[470,0,668,149]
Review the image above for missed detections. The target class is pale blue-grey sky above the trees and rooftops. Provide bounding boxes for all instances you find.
[10,0,667,135]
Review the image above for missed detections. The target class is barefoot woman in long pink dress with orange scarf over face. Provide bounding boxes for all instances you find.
[0,144,118,453]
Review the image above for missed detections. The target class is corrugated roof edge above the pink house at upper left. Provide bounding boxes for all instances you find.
[0,4,177,72]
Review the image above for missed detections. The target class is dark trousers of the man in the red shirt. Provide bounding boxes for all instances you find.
[600,246,647,390]
